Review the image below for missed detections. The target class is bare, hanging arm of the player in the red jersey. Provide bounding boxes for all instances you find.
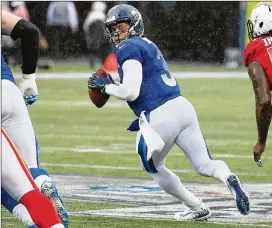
[248,61,272,166]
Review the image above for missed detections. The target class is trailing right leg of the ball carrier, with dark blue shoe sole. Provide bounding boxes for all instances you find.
[175,98,250,214]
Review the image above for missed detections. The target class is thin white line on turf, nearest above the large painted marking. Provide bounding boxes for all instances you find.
[41,162,272,177]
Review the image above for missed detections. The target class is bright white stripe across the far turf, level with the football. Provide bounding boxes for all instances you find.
[13,70,248,80]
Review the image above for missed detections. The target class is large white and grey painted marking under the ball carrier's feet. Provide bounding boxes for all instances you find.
[53,175,272,227]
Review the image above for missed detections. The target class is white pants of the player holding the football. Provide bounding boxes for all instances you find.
[136,96,231,208]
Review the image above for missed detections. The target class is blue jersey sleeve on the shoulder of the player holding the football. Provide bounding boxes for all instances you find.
[117,43,143,66]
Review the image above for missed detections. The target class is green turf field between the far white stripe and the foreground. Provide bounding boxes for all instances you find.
[2,75,272,228]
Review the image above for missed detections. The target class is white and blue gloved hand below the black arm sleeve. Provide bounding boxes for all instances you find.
[18,73,39,105]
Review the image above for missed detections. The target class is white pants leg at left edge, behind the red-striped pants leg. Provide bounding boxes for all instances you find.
[1,80,38,168]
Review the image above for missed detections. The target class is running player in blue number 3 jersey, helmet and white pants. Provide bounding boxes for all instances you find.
[88,4,250,221]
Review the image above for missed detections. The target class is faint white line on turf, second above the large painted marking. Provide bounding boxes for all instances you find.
[40,146,272,159]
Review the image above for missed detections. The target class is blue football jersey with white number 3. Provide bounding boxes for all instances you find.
[116,36,180,116]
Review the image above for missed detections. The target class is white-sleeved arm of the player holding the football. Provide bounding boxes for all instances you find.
[105,59,143,101]
